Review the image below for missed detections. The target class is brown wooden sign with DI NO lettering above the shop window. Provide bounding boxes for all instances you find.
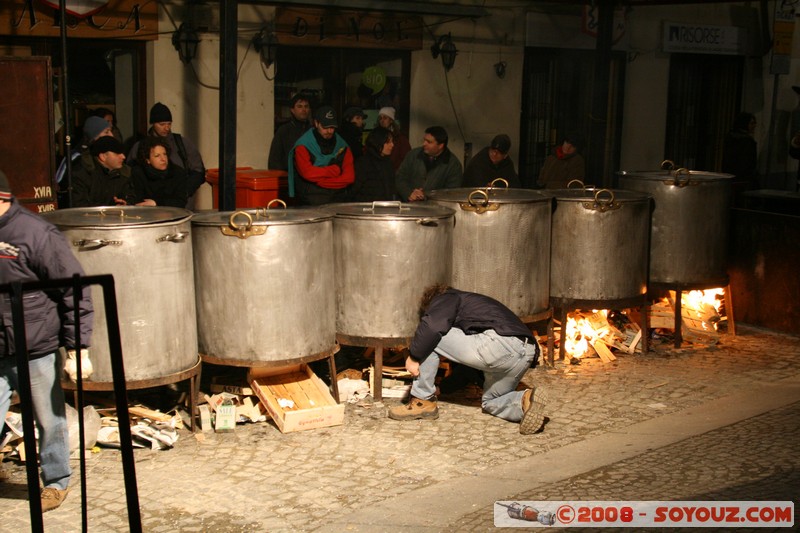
[275,8,422,50]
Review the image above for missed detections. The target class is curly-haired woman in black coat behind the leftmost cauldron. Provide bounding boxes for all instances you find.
[132,137,189,208]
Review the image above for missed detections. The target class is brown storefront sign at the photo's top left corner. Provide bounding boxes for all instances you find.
[0,0,158,40]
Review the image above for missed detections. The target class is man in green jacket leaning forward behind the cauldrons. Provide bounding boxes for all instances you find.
[395,126,464,202]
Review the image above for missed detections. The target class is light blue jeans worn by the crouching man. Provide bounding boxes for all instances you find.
[411,328,538,422]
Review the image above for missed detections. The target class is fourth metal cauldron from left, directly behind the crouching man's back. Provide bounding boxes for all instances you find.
[428,187,553,318]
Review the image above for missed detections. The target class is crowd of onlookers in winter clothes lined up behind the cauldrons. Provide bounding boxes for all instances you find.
[57,92,585,209]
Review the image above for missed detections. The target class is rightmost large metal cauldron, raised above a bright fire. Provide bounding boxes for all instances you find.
[618,169,733,286]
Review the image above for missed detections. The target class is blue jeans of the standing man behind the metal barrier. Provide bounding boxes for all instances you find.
[0,353,71,490]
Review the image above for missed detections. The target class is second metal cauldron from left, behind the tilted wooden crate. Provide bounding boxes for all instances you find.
[192,209,336,366]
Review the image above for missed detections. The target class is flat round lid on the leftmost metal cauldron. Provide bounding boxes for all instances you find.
[42,206,192,227]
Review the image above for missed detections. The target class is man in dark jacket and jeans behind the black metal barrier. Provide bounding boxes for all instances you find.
[0,171,94,511]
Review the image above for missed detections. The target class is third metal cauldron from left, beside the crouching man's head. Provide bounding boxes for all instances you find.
[327,202,454,338]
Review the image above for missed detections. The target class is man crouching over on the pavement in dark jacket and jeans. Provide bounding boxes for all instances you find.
[389,285,546,435]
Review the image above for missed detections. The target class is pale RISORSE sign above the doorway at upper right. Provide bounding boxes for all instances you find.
[663,22,747,55]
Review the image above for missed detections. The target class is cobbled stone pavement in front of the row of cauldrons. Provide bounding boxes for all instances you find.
[0,325,800,531]
